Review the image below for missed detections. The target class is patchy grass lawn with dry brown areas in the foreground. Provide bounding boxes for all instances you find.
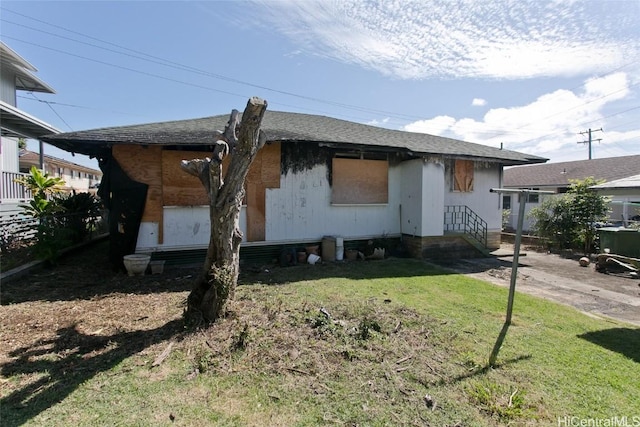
[0,251,640,426]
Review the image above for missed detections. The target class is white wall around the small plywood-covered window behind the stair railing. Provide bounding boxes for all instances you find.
[444,162,504,231]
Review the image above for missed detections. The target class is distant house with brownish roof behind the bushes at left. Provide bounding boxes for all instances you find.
[20,149,102,193]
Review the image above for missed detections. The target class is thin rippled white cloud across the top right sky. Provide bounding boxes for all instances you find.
[254,0,640,79]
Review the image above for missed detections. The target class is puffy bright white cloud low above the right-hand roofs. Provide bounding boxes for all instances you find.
[403,72,640,159]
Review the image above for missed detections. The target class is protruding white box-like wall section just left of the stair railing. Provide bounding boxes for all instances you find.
[401,159,445,237]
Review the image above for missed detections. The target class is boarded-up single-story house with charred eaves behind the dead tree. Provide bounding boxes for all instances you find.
[44,111,546,260]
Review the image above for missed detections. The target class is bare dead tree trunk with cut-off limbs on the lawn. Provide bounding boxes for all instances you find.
[181,97,267,324]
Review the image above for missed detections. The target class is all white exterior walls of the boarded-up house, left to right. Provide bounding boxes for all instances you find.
[136,159,501,251]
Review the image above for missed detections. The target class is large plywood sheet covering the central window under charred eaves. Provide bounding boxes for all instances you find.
[331,158,389,204]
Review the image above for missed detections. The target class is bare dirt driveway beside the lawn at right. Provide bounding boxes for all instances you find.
[441,244,640,325]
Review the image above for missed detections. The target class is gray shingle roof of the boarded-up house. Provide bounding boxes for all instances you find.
[42,111,547,165]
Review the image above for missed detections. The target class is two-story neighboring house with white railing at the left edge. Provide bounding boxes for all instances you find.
[0,42,59,215]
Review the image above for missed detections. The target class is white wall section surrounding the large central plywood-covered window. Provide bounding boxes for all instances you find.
[265,165,402,242]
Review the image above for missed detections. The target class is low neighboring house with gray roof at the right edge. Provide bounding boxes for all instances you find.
[502,155,640,230]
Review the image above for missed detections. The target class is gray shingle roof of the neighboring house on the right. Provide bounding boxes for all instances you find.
[503,155,640,188]
